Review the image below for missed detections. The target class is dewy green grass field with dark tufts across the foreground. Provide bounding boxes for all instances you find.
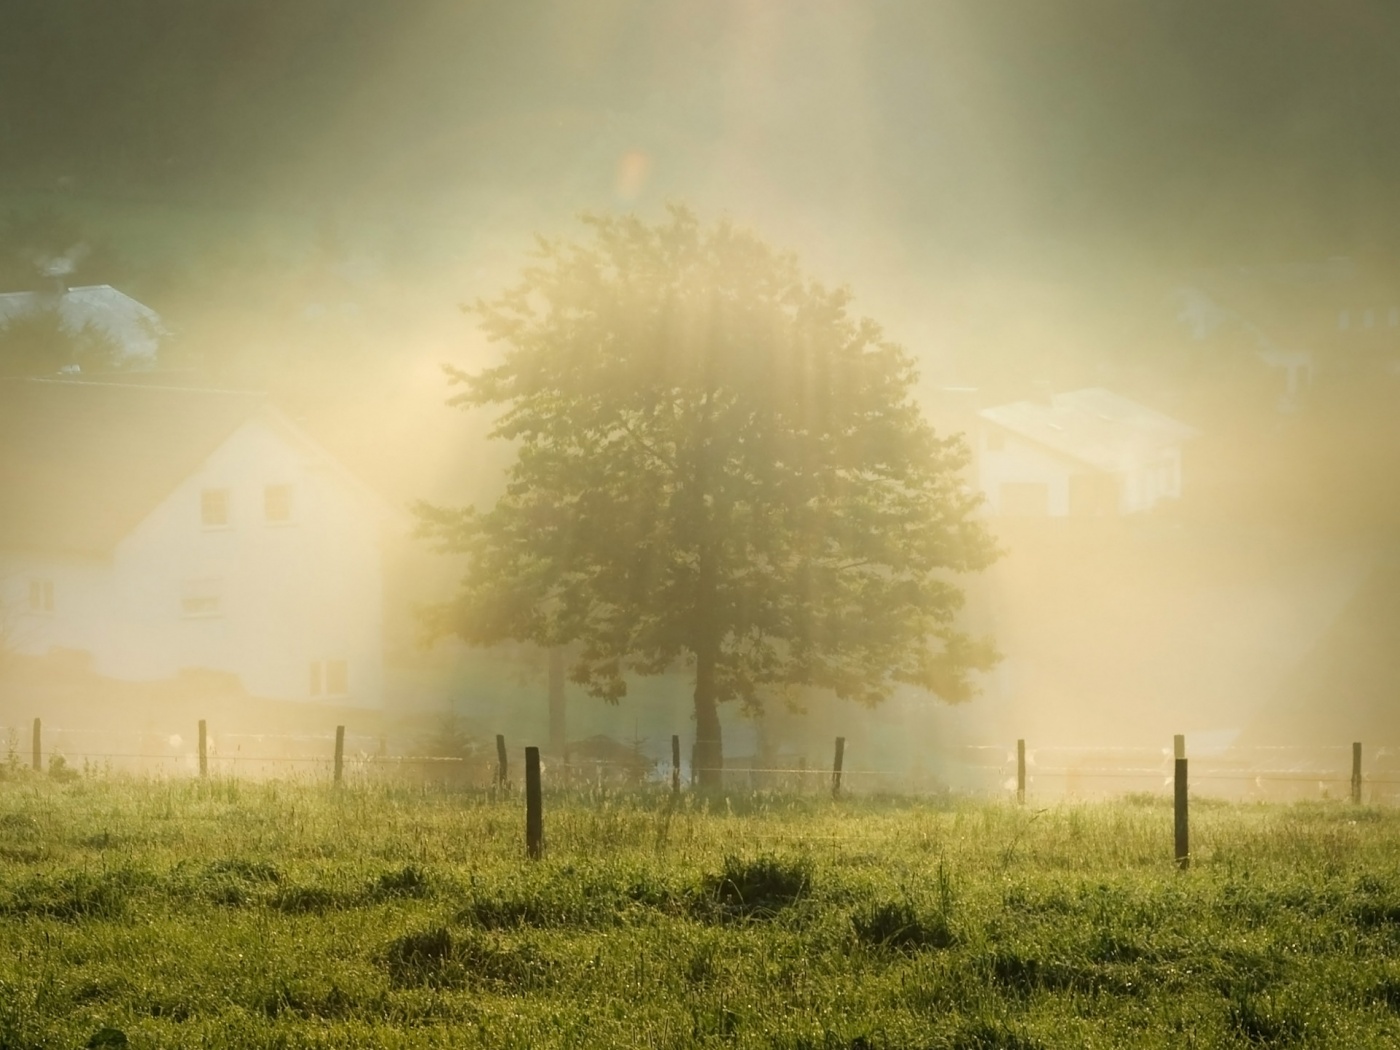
[0,769,1400,1050]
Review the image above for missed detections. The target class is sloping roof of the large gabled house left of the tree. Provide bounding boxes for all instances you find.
[0,379,270,554]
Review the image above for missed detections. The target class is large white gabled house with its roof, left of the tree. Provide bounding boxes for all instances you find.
[0,379,386,707]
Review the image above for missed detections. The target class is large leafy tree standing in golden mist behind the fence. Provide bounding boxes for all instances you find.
[419,207,997,787]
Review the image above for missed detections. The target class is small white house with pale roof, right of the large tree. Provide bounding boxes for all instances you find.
[977,386,1196,517]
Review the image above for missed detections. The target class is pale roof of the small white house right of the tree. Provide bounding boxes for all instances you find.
[977,386,1196,472]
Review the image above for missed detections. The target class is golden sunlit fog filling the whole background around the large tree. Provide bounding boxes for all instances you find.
[0,0,1400,788]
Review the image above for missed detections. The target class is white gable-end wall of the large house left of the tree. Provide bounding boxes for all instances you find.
[8,420,384,707]
